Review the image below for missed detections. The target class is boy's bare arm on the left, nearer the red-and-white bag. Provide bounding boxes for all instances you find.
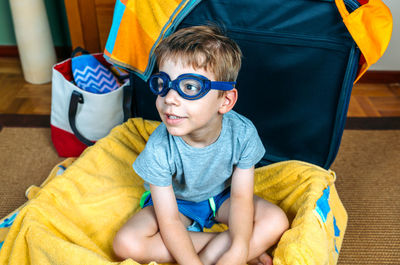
[150,184,202,265]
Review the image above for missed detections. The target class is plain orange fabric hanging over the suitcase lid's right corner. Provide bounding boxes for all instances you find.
[335,0,393,83]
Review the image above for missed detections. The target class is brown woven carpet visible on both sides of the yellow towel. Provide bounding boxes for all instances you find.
[0,127,400,265]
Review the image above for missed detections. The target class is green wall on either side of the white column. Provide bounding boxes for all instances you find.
[0,0,71,47]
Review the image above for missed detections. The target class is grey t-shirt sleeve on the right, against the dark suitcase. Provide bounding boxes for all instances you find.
[237,124,265,169]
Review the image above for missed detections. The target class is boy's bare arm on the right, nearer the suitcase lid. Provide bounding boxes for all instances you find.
[217,167,254,264]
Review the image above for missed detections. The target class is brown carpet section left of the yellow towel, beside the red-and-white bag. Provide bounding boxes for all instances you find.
[0,127,63,218]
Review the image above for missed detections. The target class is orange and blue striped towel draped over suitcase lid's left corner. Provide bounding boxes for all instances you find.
[104,0,201,81]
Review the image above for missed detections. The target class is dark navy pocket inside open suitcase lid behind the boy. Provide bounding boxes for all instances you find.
[227,29,359,168]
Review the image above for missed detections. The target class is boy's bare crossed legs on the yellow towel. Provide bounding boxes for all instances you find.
[114,196,288,265]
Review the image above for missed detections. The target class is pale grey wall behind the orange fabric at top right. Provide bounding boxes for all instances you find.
[370,0,400,71]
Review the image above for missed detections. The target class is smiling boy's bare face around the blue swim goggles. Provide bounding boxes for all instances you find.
[156,60,230,147]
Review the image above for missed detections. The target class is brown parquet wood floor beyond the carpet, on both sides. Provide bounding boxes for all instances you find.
[0,58,400,117]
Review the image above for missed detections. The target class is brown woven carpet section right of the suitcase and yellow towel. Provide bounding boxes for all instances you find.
[332,130,400,265]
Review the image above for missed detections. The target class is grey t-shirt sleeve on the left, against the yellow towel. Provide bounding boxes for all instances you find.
[133,128,174,186]
